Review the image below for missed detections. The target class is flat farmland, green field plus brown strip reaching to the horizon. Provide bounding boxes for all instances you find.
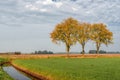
[0,54,120,80]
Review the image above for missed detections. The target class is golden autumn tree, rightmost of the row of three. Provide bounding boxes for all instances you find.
[91,23,113,53]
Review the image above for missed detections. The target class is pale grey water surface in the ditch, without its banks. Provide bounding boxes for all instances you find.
[3,66,31,80]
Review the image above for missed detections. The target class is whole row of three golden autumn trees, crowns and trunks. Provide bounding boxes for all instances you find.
[50,18,113,56]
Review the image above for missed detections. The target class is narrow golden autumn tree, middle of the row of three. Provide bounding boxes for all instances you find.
[76,23,91,54]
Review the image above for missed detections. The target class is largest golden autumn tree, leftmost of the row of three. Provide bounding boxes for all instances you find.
[50,18,78,56]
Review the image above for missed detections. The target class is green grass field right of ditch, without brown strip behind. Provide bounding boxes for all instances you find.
[13,58,120,80]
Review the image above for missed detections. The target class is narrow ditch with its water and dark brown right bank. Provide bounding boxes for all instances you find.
[0,62,48,80]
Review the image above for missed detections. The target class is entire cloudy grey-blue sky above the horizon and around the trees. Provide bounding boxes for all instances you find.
[0,0,120,52]
